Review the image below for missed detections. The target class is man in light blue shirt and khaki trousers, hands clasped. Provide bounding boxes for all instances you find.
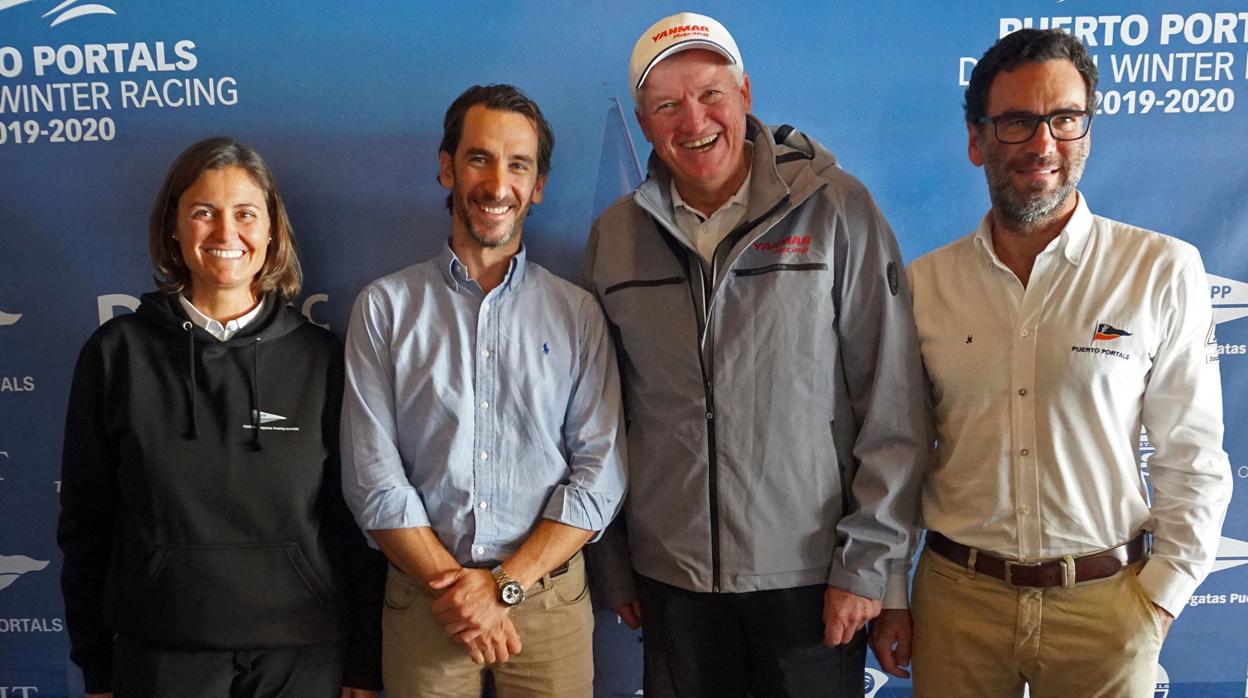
[342,85,626,698]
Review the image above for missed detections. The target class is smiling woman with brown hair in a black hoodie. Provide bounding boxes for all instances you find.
[57,139,384,698]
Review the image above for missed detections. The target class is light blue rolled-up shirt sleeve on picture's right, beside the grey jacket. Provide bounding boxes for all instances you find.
[542,293,628,541]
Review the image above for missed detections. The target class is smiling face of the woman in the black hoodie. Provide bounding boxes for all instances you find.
[175,166,271,307]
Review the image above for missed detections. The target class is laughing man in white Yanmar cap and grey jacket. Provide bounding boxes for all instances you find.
[585,14,931,698]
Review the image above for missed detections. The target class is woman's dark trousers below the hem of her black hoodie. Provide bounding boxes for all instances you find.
[112,636,343,698]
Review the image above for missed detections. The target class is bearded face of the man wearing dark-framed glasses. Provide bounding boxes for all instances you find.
[967,59,1092,230]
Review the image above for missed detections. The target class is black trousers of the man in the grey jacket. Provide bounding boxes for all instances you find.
[638,577,866,698]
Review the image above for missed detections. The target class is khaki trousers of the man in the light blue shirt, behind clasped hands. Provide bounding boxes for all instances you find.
[382,553,594,698]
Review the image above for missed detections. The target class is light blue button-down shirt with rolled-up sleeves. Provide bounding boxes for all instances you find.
[342,247,628,564]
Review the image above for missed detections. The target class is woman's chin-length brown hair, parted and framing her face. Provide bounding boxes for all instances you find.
[147,136,303,301]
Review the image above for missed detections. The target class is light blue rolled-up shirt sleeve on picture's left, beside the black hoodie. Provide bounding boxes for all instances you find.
[342,286,429,531]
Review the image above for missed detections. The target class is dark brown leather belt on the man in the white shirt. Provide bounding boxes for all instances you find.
[927,531,1147,587]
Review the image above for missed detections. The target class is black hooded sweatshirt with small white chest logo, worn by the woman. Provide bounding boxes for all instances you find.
[57,293,384,693]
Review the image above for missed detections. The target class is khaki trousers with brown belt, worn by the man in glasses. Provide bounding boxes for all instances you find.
[911,549,1162,698]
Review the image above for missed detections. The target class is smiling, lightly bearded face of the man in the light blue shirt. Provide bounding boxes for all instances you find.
[438,105,545,248]
